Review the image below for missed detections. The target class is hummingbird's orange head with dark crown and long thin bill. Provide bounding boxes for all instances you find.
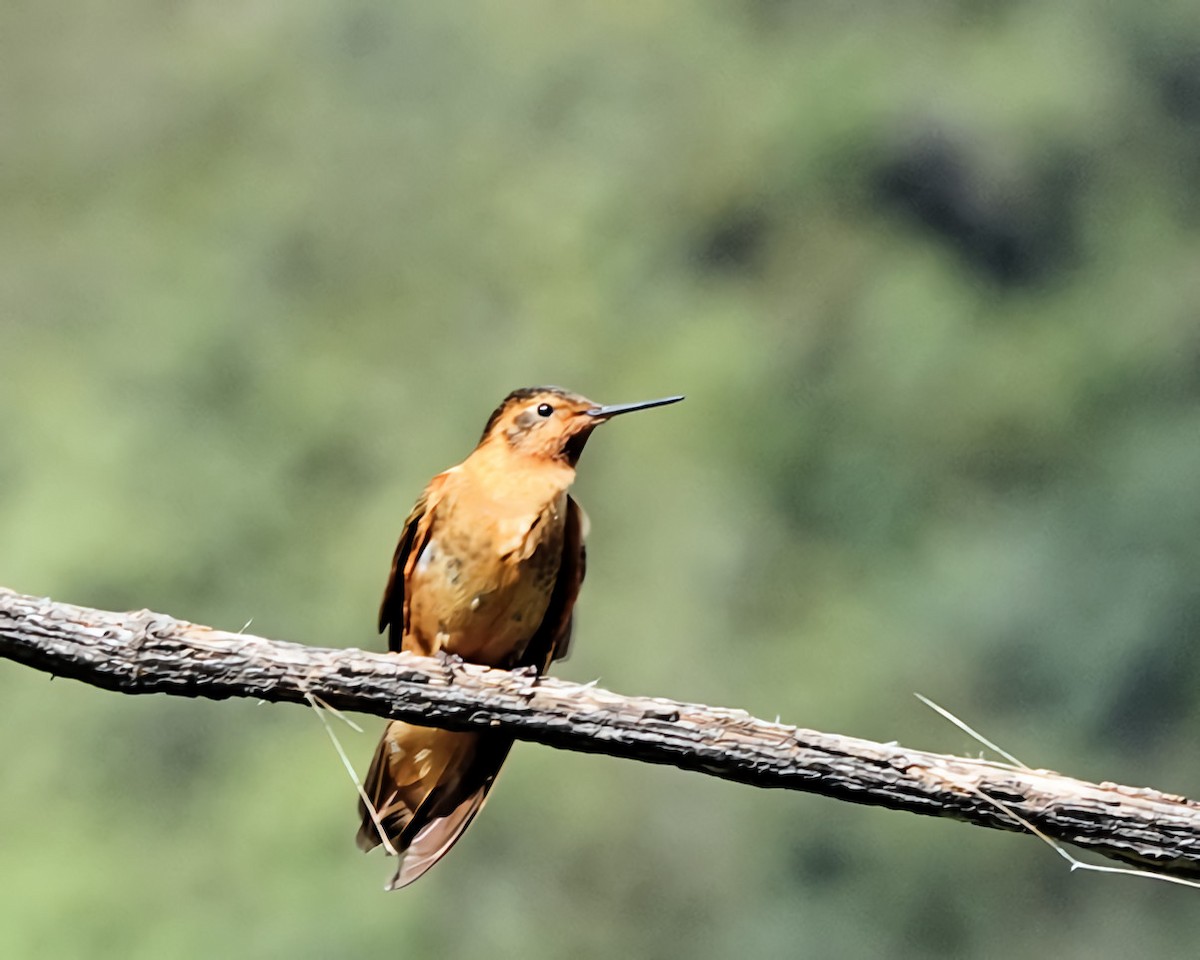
[480,386,683,467]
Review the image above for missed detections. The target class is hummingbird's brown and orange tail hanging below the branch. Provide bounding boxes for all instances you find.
[358,720,512,890]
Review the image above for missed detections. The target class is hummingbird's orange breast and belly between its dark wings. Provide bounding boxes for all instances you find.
[406,491,566,667]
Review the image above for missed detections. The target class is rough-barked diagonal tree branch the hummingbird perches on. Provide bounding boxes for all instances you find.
[0,588,1200,877]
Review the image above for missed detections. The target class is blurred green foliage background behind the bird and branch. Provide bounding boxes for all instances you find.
[0,0,1200,960]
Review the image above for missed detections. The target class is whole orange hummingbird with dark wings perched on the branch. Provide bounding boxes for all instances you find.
[358,386,683,890]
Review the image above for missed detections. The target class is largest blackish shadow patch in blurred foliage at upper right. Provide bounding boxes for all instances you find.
[872,132,1081,287]
